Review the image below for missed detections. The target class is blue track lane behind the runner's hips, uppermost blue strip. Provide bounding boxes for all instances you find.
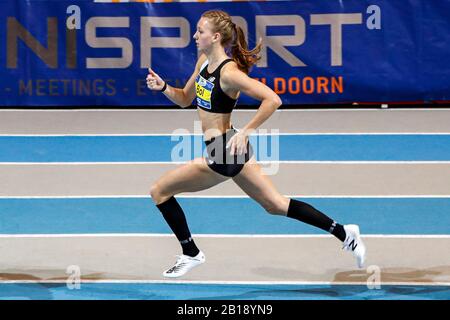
[0,135,450,162]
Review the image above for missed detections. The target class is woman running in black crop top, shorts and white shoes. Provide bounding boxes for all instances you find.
[147,10,366,278]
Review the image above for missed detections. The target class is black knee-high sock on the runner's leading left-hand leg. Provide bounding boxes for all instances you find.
[156,197,200,257]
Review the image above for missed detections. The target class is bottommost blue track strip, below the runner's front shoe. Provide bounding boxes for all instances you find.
[0,283,450,300]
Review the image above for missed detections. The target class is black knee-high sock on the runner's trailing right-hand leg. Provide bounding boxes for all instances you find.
[287,199,345,241]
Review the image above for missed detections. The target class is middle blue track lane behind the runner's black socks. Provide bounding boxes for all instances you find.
[0,197,450,234]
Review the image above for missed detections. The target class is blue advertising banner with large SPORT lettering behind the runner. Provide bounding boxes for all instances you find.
[0,0,450,106]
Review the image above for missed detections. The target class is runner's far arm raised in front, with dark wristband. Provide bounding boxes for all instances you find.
[147,54,206,108]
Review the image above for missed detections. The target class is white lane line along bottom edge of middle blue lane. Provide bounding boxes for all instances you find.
[0,233,450,239]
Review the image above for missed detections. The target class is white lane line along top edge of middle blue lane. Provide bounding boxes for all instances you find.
[0,194,450,200]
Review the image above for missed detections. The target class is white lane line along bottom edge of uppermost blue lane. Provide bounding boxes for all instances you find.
[0,160,450,166]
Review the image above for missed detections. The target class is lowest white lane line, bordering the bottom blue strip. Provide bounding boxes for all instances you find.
[0,276,450,286]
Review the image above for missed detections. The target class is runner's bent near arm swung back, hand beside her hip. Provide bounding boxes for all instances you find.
[221,64,282,154]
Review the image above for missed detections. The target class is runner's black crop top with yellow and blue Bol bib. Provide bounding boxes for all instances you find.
[195,59,237,113]
